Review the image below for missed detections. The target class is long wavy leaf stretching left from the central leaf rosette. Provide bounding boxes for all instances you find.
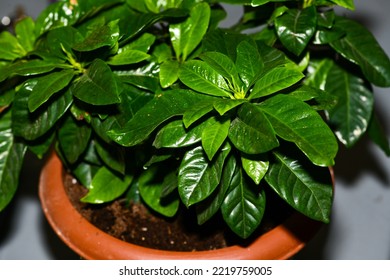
[108,90,209,146]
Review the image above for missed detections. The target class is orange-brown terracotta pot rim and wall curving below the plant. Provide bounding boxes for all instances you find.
[39,153,321,260]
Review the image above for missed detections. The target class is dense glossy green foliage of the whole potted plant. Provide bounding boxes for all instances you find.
[0,0,390,257]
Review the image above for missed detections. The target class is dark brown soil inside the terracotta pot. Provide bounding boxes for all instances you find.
[64,171,291,251]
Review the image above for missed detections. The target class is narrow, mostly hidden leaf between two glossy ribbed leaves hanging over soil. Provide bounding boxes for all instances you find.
[196,156,237,225]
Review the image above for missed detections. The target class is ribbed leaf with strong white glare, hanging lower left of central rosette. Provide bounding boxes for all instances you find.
[178,143,230,207]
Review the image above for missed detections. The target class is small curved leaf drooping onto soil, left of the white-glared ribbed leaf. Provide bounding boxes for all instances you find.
[138,166,180,217]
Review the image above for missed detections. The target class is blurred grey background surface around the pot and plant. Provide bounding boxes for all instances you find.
[0,0,390,260]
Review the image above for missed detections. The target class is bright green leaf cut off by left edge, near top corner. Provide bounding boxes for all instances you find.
[0,31,27,60]
